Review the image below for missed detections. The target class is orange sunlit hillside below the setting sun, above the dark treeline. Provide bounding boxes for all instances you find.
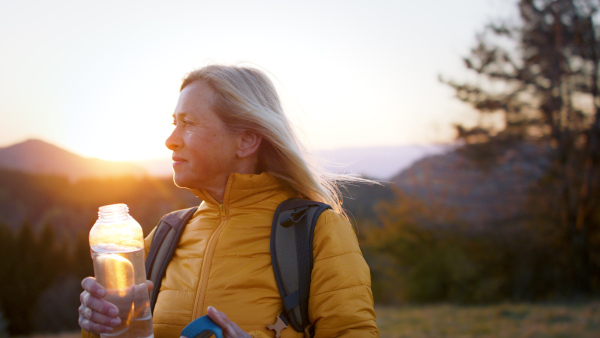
[0,168,198,235]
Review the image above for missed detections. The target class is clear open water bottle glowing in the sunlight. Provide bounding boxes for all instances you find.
[90,204,154,338]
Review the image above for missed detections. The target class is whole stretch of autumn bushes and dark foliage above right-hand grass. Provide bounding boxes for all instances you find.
[361,185,596,304]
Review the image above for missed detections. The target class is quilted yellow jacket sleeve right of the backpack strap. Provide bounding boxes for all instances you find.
[308,210,379,338]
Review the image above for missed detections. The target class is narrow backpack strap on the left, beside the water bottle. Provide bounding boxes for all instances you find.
[146,207,198,313]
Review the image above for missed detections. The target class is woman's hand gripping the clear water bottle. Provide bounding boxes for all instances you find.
[78,277,121,334]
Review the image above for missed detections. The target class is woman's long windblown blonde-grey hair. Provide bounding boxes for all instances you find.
[180,65,367,215]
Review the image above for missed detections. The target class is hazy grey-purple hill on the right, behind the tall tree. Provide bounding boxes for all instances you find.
[392,145,548,229]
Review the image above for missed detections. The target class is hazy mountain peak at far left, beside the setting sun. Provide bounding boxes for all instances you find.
[0,139,146,181]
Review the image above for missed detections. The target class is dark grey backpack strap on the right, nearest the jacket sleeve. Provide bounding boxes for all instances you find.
[271,198,331,332]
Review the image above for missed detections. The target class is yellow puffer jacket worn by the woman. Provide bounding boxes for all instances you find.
[82,173,378,338]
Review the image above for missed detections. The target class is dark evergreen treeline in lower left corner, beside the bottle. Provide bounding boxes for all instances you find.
[0,223,93,334]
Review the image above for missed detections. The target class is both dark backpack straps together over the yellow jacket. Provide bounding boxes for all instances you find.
[146,198,331,337]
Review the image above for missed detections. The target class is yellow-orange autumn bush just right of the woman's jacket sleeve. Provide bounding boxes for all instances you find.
[361,192,497,303]
